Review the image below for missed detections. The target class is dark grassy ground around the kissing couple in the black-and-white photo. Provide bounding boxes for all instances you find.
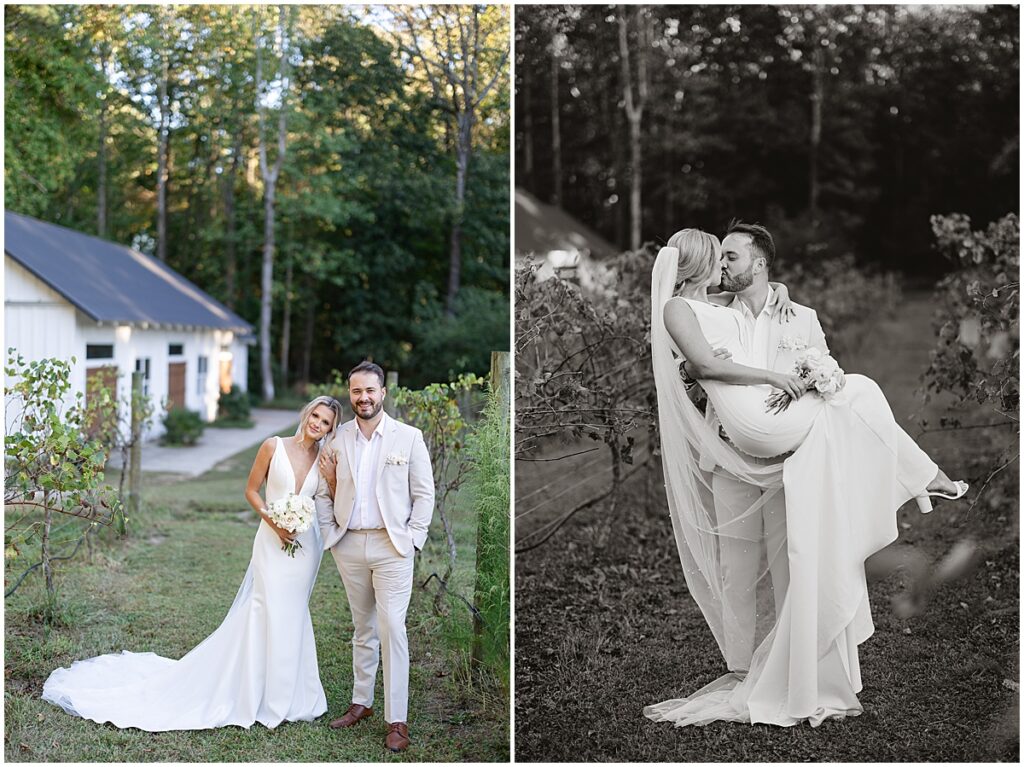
[515,290,1020,762]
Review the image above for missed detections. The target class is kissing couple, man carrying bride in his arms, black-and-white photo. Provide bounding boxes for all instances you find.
[644,222,968,727]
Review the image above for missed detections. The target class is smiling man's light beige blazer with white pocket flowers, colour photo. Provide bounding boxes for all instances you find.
[315,417,434,557]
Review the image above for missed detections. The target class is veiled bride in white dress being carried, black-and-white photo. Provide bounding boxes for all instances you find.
[644,229,967,726]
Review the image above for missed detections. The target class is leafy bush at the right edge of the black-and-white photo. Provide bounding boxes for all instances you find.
[923,213,1020,420]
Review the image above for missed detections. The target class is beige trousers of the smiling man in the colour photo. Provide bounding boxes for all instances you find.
[331,529,413,723]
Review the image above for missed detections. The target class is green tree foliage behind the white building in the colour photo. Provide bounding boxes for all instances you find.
[5,5,509,391]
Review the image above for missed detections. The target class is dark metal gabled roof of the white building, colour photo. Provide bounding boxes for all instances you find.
[4,211,252,333]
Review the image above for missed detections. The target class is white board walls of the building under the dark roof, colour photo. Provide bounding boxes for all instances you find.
[4,257,248,438]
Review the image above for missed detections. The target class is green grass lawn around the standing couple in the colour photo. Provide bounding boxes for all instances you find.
[4,423,509,762]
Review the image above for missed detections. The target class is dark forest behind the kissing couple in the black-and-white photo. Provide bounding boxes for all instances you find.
[515,5,1020,282]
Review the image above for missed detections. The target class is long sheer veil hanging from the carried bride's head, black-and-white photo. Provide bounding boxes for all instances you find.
[645,247,785,719]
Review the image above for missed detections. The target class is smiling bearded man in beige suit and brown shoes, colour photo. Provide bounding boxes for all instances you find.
[316,361,434,752]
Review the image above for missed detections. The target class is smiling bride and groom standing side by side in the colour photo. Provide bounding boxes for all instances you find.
[43,361,434,752]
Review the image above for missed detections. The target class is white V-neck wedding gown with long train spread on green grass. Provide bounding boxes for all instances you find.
[43,437,327,732]
